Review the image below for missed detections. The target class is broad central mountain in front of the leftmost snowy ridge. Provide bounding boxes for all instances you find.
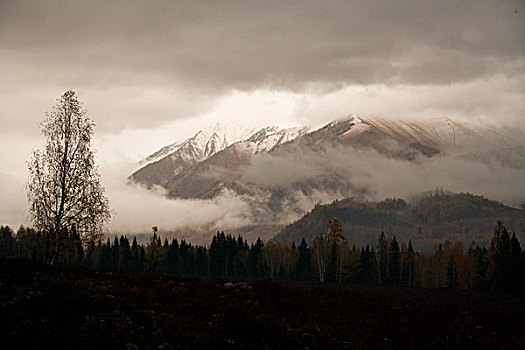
[163,115,525,208]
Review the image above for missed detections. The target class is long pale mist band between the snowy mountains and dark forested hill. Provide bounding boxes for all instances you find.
[103,141,525,241]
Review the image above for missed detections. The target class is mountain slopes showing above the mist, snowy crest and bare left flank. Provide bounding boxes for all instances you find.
[130,115,525,194]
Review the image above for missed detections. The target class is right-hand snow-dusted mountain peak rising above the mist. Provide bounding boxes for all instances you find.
[273,115,517,160]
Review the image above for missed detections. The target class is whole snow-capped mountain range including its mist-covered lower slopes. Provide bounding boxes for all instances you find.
[129,115,525,243]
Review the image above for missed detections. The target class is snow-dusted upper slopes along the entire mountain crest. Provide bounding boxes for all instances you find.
[137,114,508,187]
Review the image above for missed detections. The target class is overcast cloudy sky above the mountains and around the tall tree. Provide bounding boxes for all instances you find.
[0,0,525,235]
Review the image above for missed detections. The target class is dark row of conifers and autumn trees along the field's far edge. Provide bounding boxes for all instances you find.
[0,218,525,292]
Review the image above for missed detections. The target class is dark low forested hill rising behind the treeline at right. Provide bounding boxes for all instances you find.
[274,191,525,252]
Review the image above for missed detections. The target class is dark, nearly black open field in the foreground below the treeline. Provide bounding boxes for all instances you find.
[0,259,525,349]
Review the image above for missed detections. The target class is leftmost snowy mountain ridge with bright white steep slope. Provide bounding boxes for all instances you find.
[129,123,256,187]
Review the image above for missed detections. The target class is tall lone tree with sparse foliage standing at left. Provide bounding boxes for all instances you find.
[27,90,111,263]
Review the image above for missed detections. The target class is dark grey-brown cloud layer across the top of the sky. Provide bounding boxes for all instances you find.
[0,0,525,89]
